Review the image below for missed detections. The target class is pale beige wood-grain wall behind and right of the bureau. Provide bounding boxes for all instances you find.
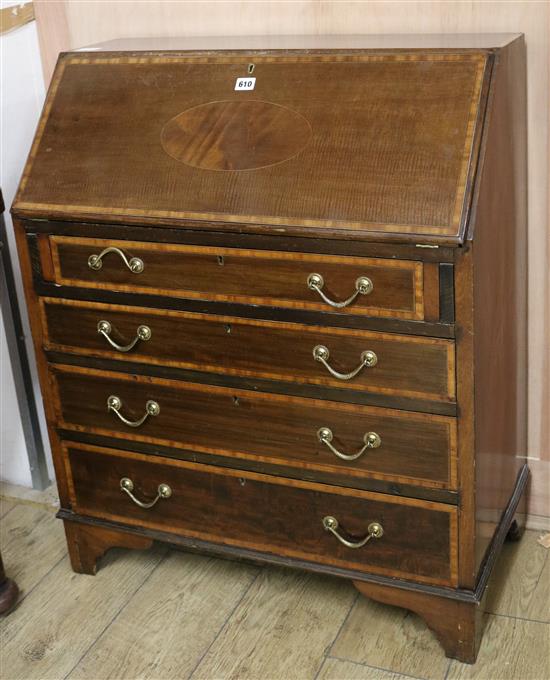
[38,0,550,515]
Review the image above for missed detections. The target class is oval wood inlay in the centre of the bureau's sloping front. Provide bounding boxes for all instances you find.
[161,100,312,170]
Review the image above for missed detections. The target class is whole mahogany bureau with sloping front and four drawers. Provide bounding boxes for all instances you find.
[13,35,529,662]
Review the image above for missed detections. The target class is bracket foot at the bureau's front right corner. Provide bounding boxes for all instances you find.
[353,581,482,663]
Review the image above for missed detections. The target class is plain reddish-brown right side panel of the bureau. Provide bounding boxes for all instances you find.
[471,37,527,571]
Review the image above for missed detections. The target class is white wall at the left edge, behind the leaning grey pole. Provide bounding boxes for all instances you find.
[0,1,53,486]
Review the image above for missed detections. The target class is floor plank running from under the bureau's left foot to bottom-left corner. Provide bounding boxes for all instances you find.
[0,540,166,680]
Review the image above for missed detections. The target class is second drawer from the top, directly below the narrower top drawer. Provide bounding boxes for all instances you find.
[41,298,455,402]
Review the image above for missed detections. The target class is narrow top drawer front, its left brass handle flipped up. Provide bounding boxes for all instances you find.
[50,236,426,320]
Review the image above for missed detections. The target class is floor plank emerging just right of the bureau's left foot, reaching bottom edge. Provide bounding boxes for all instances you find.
[70,551,259,680]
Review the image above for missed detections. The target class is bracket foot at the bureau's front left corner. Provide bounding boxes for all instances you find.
[64,522,153,575]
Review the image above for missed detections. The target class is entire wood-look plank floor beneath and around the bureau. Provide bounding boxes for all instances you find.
[0,488,550,680]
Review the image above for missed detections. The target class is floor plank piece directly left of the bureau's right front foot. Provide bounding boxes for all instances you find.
[330,596,448,680]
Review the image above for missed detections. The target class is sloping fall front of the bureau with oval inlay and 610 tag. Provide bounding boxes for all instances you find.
[14,36,504,243]
